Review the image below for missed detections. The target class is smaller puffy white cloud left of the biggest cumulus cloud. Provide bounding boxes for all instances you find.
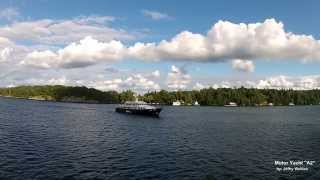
[20,36,125,68]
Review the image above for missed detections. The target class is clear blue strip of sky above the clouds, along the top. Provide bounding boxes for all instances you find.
[0,0,319,32]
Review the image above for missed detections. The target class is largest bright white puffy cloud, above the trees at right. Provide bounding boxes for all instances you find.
[129,19,320,62]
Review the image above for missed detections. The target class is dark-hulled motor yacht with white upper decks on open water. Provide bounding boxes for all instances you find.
[116,101,162,117]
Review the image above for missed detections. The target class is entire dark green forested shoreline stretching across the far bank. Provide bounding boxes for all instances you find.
[0,85,320,106]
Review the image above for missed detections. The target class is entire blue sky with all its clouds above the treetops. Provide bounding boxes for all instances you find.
[0,0,320,93]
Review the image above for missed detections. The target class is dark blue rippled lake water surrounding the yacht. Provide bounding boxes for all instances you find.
[0,98,320,179]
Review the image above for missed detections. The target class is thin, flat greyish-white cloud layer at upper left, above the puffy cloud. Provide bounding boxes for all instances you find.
[0,16,135,45]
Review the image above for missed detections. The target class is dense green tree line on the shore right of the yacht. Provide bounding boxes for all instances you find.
[142,87,320,106]
